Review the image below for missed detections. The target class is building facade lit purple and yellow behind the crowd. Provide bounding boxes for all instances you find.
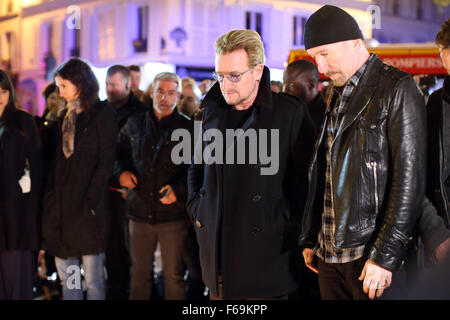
[0,0,439,114]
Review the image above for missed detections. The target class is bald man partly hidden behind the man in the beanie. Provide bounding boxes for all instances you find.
[283,60,326,132]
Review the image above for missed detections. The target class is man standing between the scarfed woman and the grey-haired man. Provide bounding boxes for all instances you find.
[105,65,148,299]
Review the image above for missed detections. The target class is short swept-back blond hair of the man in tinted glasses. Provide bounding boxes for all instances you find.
[214,29,266,67]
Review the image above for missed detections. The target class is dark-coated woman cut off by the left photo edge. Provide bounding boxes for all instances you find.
[0,70,42,300]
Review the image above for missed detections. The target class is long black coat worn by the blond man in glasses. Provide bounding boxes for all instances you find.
[187,68,315,299]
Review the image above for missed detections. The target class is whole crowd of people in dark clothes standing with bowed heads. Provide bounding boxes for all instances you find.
[0,5,450,300]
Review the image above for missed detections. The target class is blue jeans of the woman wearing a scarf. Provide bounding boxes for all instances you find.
[55,253,105,300]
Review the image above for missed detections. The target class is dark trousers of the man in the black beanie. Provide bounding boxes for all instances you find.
[317,257,369,300]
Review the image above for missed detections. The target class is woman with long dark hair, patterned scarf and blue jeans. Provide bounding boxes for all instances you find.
[42,58,117,300]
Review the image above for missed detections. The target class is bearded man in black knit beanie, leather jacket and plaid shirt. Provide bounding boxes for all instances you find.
[299,5,426,299]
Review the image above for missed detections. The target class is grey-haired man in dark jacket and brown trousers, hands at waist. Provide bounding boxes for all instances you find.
[116,72,192,300]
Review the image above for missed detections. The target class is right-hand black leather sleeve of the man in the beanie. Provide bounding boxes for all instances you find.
[369,77,427,271]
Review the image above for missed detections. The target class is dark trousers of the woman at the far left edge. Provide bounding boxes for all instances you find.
[0,251,37,300]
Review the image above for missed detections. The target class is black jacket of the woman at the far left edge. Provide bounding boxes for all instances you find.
[0,110,42,252]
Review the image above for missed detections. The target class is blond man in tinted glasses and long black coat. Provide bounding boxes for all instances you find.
[188,30,315,299]
